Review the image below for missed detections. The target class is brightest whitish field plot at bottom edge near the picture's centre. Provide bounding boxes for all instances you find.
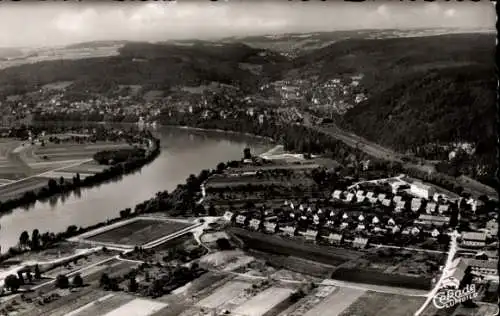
[233,287,294,316]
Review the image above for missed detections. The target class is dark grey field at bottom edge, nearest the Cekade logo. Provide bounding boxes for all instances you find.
[336,291,425,316]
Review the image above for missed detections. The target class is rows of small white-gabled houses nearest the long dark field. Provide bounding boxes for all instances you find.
[224,192,449,247]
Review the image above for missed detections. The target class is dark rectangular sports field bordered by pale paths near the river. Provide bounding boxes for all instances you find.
[86,219,190,245]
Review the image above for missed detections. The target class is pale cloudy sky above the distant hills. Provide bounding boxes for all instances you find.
[0,0,496,47]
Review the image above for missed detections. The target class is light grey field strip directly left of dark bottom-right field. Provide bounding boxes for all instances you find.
[304,287,366,316]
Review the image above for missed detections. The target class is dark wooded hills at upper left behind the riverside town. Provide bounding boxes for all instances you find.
[0,43,284,95]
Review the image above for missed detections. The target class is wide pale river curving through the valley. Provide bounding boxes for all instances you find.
[0,127,273,252]
